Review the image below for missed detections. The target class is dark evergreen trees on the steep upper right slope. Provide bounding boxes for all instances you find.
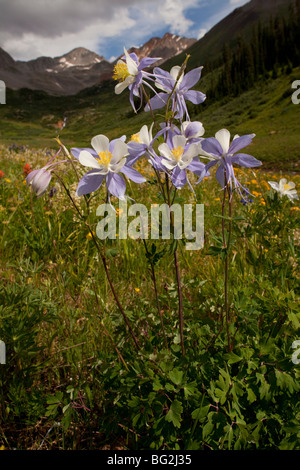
[211,0,300,98]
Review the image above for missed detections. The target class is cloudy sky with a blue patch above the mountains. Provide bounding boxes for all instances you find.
[0,0,249,61]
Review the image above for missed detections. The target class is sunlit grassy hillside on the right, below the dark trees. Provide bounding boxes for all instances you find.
[197,67,300,171]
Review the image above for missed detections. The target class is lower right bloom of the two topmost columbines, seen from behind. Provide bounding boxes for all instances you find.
[145,65,206,119]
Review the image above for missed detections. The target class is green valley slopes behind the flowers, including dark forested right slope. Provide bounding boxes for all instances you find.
[0,0,300,171]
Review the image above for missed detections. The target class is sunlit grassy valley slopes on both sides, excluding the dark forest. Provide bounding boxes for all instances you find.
[0,67,300,170]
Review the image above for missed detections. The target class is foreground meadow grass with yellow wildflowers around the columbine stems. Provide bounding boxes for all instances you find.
[0,141,300,450]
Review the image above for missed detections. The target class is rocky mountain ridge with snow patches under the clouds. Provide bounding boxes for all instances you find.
[0,33,196,95]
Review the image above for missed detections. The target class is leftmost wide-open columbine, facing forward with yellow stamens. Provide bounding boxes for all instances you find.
[71,134,146,200]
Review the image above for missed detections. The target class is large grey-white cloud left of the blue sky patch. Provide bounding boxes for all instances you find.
[0,0,136,60]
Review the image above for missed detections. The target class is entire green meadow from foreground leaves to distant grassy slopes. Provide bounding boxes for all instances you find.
[0,61,300,451]
